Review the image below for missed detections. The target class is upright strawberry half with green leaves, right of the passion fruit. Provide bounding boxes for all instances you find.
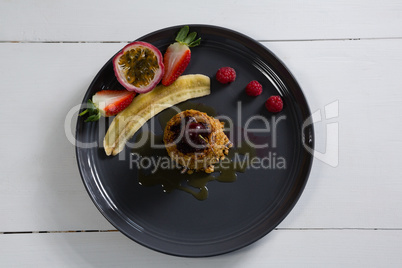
[162,26,201,86]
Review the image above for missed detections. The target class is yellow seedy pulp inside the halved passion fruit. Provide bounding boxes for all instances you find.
[119,47,159,87]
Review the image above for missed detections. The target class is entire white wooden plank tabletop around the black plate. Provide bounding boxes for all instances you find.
[0,0,402,267]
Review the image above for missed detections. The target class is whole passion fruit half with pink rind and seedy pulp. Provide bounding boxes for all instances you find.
[113,41,165,93]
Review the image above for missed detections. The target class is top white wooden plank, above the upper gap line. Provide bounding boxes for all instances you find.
[0,0,402,41]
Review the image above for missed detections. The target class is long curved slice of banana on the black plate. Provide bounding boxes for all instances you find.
[103,74,211,155]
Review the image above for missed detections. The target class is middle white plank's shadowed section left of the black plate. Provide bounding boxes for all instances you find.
[0,44,121,231]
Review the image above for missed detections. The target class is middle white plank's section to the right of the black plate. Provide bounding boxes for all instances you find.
[267,40,402,227]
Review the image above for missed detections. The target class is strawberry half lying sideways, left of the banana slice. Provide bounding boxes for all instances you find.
[80,90,136,122]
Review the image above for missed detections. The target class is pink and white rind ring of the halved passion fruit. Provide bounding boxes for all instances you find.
[113,41,165,93]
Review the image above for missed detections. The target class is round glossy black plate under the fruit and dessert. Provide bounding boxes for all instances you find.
[76,25,314,257]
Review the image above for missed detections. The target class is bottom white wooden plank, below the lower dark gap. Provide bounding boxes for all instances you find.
[0,230,402,268]
